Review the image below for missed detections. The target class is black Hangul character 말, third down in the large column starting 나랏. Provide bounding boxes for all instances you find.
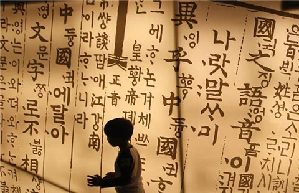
[206,78,229,101]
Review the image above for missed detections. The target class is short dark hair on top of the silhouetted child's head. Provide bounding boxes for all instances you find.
[104,118,133,140]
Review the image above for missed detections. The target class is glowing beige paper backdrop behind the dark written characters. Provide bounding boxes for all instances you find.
[1,1,299,193]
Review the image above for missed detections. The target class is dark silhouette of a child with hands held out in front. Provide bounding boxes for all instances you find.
[87,118,144,193]
